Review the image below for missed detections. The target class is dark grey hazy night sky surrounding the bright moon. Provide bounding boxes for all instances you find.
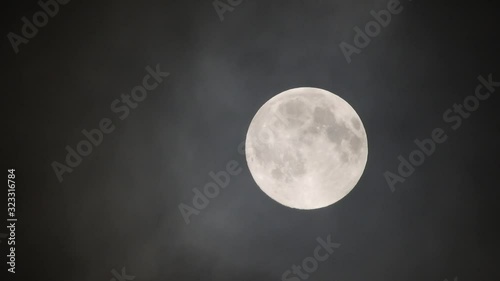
[0,0,500,281]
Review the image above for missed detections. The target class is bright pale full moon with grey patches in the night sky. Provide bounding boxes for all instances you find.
[245,88,368,210]
